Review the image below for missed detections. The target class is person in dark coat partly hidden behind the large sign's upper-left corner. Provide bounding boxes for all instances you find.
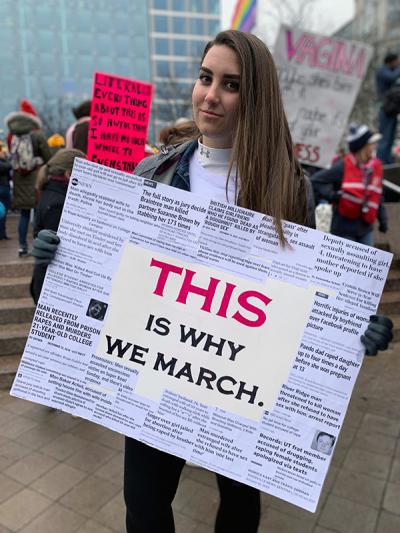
[31,148,86,304]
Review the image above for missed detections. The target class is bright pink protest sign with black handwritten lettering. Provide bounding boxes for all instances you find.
[87,72,153,172]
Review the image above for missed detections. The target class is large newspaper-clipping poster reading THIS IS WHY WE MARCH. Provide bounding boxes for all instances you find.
[11,159,392,512]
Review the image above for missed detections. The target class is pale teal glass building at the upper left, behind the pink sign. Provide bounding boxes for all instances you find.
[0,0,151,137]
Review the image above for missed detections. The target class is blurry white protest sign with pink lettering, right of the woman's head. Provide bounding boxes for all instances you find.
[274,26,372,167]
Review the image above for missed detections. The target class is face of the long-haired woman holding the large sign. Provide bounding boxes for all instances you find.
[192,45,240,148]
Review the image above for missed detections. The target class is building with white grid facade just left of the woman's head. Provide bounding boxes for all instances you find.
[149,0,221,131]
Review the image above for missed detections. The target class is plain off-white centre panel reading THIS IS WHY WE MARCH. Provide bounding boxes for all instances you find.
[97,243,315,421]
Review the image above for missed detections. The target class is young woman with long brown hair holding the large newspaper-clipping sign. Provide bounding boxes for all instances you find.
[35,30,390,533]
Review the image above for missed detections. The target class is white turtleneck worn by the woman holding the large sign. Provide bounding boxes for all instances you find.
[189,141,237,204]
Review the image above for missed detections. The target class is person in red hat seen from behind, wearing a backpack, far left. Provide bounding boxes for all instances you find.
[4,100,51,257]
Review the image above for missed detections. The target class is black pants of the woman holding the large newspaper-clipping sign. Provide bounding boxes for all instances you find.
[124,437,260,533]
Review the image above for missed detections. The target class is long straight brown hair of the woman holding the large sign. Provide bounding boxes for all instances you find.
[201,30,307,245]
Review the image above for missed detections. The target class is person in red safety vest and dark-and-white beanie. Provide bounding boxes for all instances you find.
[311,123,387,246]
